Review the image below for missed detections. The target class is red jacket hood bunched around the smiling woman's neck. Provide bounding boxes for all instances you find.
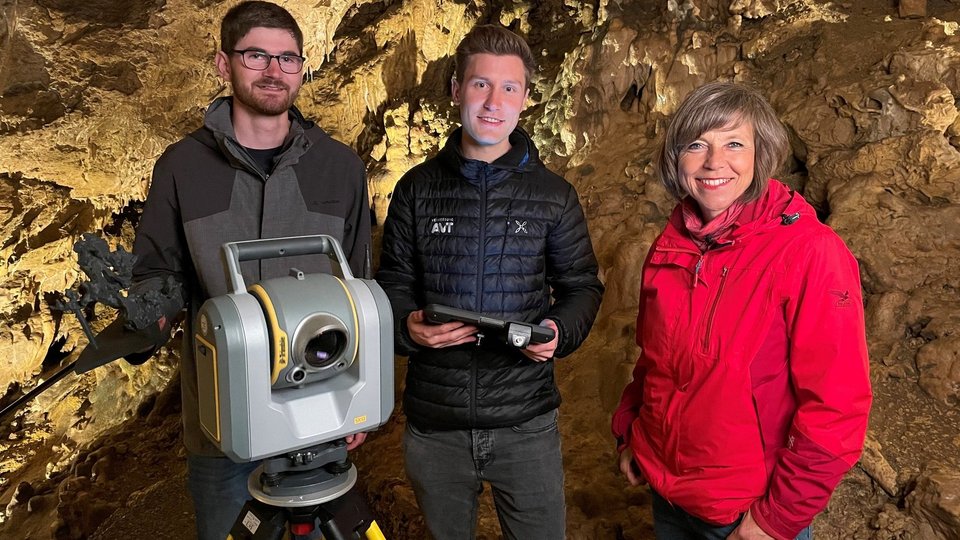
[662,178,817,248]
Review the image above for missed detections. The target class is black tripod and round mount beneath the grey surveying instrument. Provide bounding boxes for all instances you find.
[227,439,384,540]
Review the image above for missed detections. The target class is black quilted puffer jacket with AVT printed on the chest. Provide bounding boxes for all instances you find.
[377,128,603,429]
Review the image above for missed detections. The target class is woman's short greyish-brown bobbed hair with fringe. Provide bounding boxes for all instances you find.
[654,82,790,202]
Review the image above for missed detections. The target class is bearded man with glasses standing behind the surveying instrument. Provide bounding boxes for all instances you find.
[128,1,370,540]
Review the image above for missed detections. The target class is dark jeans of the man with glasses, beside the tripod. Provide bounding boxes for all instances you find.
[187,454,259,540]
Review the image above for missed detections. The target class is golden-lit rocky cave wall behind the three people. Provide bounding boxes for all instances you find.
[0,0,960,538]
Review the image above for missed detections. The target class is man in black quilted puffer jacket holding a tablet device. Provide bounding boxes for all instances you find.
[377,26,603,540]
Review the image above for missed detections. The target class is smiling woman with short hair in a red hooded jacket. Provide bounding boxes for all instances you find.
[613,83,872,540]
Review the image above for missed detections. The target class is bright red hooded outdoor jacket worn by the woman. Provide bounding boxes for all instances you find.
[612,179,872,540]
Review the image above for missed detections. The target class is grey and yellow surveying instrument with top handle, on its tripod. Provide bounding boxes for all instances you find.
[194,235,394,540]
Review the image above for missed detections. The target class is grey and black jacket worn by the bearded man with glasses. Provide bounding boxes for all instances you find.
[133,97,370,455]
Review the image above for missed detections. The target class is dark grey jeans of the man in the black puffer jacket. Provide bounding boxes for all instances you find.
[403,409,566,540]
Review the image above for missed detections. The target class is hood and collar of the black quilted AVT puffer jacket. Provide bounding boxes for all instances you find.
[437,127,540,182]
